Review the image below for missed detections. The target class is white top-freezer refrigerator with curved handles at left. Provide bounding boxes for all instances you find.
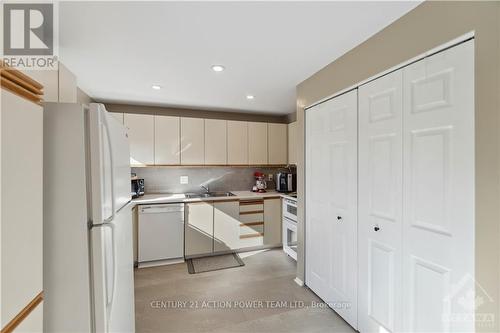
[43,103,135,333]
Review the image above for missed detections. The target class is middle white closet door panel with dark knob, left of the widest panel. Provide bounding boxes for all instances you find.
[358,70,403,333]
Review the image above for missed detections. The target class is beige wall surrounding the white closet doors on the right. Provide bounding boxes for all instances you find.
[297,2,500,332]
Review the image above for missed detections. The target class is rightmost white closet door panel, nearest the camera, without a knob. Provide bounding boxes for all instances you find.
[403,41,472,332]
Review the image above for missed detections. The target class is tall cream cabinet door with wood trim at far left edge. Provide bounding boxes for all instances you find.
[0,88,43,327]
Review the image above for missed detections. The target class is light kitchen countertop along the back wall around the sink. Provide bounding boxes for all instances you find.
[132,191,285,205]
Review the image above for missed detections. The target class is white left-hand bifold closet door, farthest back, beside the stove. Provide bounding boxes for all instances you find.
[306,90,357,328]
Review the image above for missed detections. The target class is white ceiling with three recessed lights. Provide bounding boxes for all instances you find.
[59,1,419,114]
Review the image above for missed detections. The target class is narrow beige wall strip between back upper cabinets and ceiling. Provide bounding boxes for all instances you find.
[104,103,288,123]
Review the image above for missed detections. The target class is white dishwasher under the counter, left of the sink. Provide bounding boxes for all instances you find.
[138,203,184,267]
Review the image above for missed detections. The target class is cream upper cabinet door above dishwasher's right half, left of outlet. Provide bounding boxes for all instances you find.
[155,116,181,164]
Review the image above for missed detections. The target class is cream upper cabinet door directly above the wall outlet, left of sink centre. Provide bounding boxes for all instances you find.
[181,118,205,165]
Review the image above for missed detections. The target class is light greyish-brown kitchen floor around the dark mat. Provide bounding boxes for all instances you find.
[135,249,354,333]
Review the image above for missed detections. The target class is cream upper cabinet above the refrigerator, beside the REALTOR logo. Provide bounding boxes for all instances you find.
[24,63,77,103]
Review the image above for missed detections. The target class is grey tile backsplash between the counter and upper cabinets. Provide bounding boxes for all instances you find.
[132,167,295,193]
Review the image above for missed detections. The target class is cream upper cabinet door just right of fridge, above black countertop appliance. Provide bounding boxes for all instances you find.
[123,113,154,166]
